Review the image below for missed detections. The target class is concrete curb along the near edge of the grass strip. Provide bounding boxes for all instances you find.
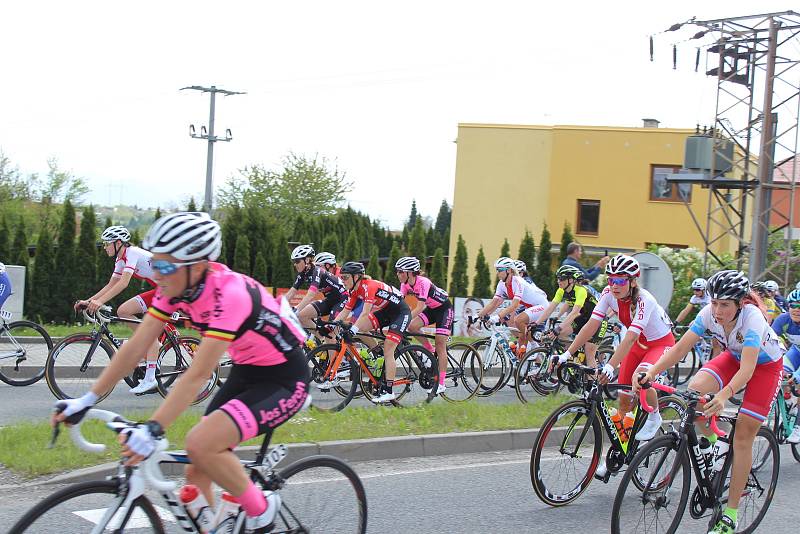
[0,428,562,490]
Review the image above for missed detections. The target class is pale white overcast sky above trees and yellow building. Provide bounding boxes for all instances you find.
[0,0,792,228]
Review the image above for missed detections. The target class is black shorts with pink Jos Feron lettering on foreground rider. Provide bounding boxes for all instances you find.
[206,347,310,441]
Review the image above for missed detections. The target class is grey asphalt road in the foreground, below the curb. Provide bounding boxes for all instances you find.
[0,447,800,534]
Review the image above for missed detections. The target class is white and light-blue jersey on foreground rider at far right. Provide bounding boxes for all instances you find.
[690,304,783,364]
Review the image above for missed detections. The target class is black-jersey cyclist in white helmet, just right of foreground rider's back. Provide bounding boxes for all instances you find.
[286,245,348,328]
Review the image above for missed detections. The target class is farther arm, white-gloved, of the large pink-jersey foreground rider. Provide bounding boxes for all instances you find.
[51,315,165,425]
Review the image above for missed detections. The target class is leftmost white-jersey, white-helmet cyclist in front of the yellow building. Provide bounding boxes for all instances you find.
[478,256,547,358]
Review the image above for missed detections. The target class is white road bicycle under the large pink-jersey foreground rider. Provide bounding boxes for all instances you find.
[9,409,367,534]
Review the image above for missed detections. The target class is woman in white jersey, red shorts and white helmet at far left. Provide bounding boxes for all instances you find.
[75,226,159,395]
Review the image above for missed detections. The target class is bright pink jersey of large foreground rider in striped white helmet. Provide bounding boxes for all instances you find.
[148,263,305,366]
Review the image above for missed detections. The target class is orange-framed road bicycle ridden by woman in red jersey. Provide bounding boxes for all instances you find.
[308,319,439,412]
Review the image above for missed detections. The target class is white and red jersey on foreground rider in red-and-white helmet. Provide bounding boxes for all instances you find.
[592,287,672,341]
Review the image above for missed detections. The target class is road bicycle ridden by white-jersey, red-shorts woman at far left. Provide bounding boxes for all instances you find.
[44,306,212,403]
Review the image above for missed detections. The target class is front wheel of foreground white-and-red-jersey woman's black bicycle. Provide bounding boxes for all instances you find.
[530,400,603,506]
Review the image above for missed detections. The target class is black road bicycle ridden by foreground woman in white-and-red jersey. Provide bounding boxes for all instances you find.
[530,362,686,506]
